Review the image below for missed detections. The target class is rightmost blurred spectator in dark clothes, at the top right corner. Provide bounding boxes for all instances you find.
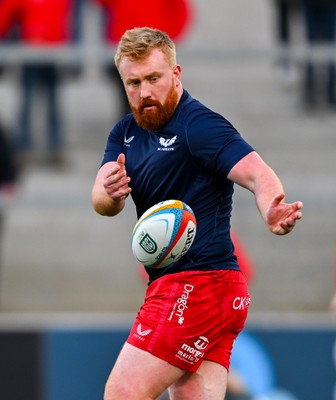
[303,0,336,106]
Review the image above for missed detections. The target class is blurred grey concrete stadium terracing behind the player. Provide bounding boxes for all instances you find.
[0,0,336,400]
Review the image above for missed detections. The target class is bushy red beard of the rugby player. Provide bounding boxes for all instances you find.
[130,85,178,131]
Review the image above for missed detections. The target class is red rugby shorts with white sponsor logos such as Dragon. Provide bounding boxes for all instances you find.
[127,270,250,371]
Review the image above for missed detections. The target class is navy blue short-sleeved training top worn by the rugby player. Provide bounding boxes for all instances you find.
[102,90,253,282]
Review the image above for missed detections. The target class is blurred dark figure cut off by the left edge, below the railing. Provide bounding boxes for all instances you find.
[0,124,18,304]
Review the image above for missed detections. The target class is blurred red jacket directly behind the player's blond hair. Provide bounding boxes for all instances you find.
[95,0,193,44]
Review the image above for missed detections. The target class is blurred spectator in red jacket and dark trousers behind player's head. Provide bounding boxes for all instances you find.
[94,0,193,118]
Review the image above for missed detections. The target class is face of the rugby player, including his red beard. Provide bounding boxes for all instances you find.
[119,49,182,130]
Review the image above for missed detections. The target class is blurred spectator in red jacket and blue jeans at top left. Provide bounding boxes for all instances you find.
[0,0,82,165]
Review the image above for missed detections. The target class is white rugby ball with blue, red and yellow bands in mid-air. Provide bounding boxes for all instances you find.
[132,200,196,268]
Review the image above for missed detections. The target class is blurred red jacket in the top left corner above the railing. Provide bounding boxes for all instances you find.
[0,0,74,46]
